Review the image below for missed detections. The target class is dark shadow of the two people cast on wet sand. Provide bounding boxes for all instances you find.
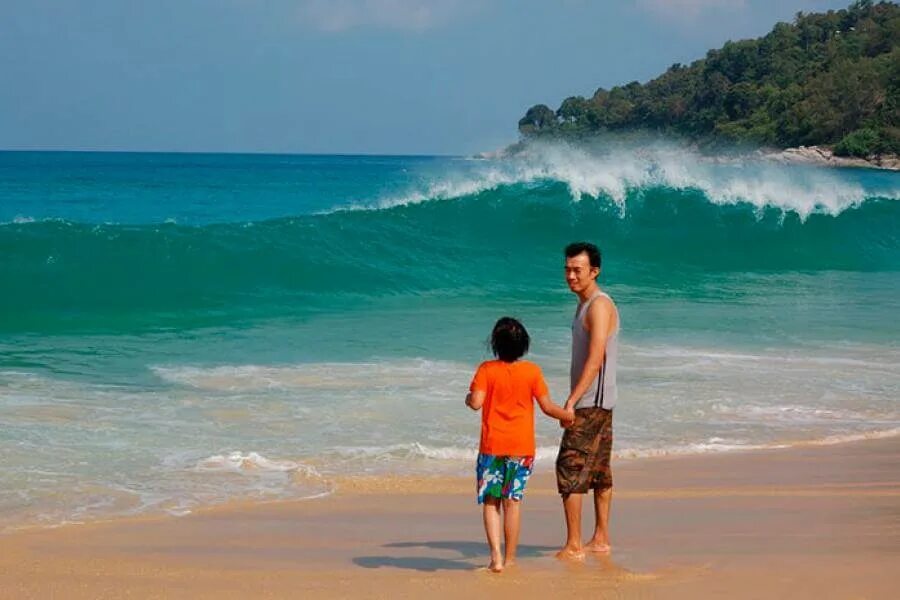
[353,541,556,572]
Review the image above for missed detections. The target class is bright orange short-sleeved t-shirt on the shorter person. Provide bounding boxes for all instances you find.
[469,360,548,456]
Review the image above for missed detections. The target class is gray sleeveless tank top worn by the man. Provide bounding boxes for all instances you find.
[569,290,621,410]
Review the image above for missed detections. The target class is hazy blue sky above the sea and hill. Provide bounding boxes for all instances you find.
[0,0,850,154]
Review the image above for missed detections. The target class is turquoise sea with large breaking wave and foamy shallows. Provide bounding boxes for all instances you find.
[0,147,900,528]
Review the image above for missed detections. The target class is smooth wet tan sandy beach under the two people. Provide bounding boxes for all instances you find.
[0,438,900,599]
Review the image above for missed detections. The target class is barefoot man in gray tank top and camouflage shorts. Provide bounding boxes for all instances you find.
[556,242,619,559]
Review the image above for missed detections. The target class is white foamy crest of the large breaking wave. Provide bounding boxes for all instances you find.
[350,143,900,219]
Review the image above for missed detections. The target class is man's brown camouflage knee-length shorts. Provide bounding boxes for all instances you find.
[556,408,612,495]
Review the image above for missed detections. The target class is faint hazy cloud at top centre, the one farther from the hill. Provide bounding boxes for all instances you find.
[300,0,478,32]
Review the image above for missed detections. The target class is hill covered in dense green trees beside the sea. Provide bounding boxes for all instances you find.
[519,0,900,156]
